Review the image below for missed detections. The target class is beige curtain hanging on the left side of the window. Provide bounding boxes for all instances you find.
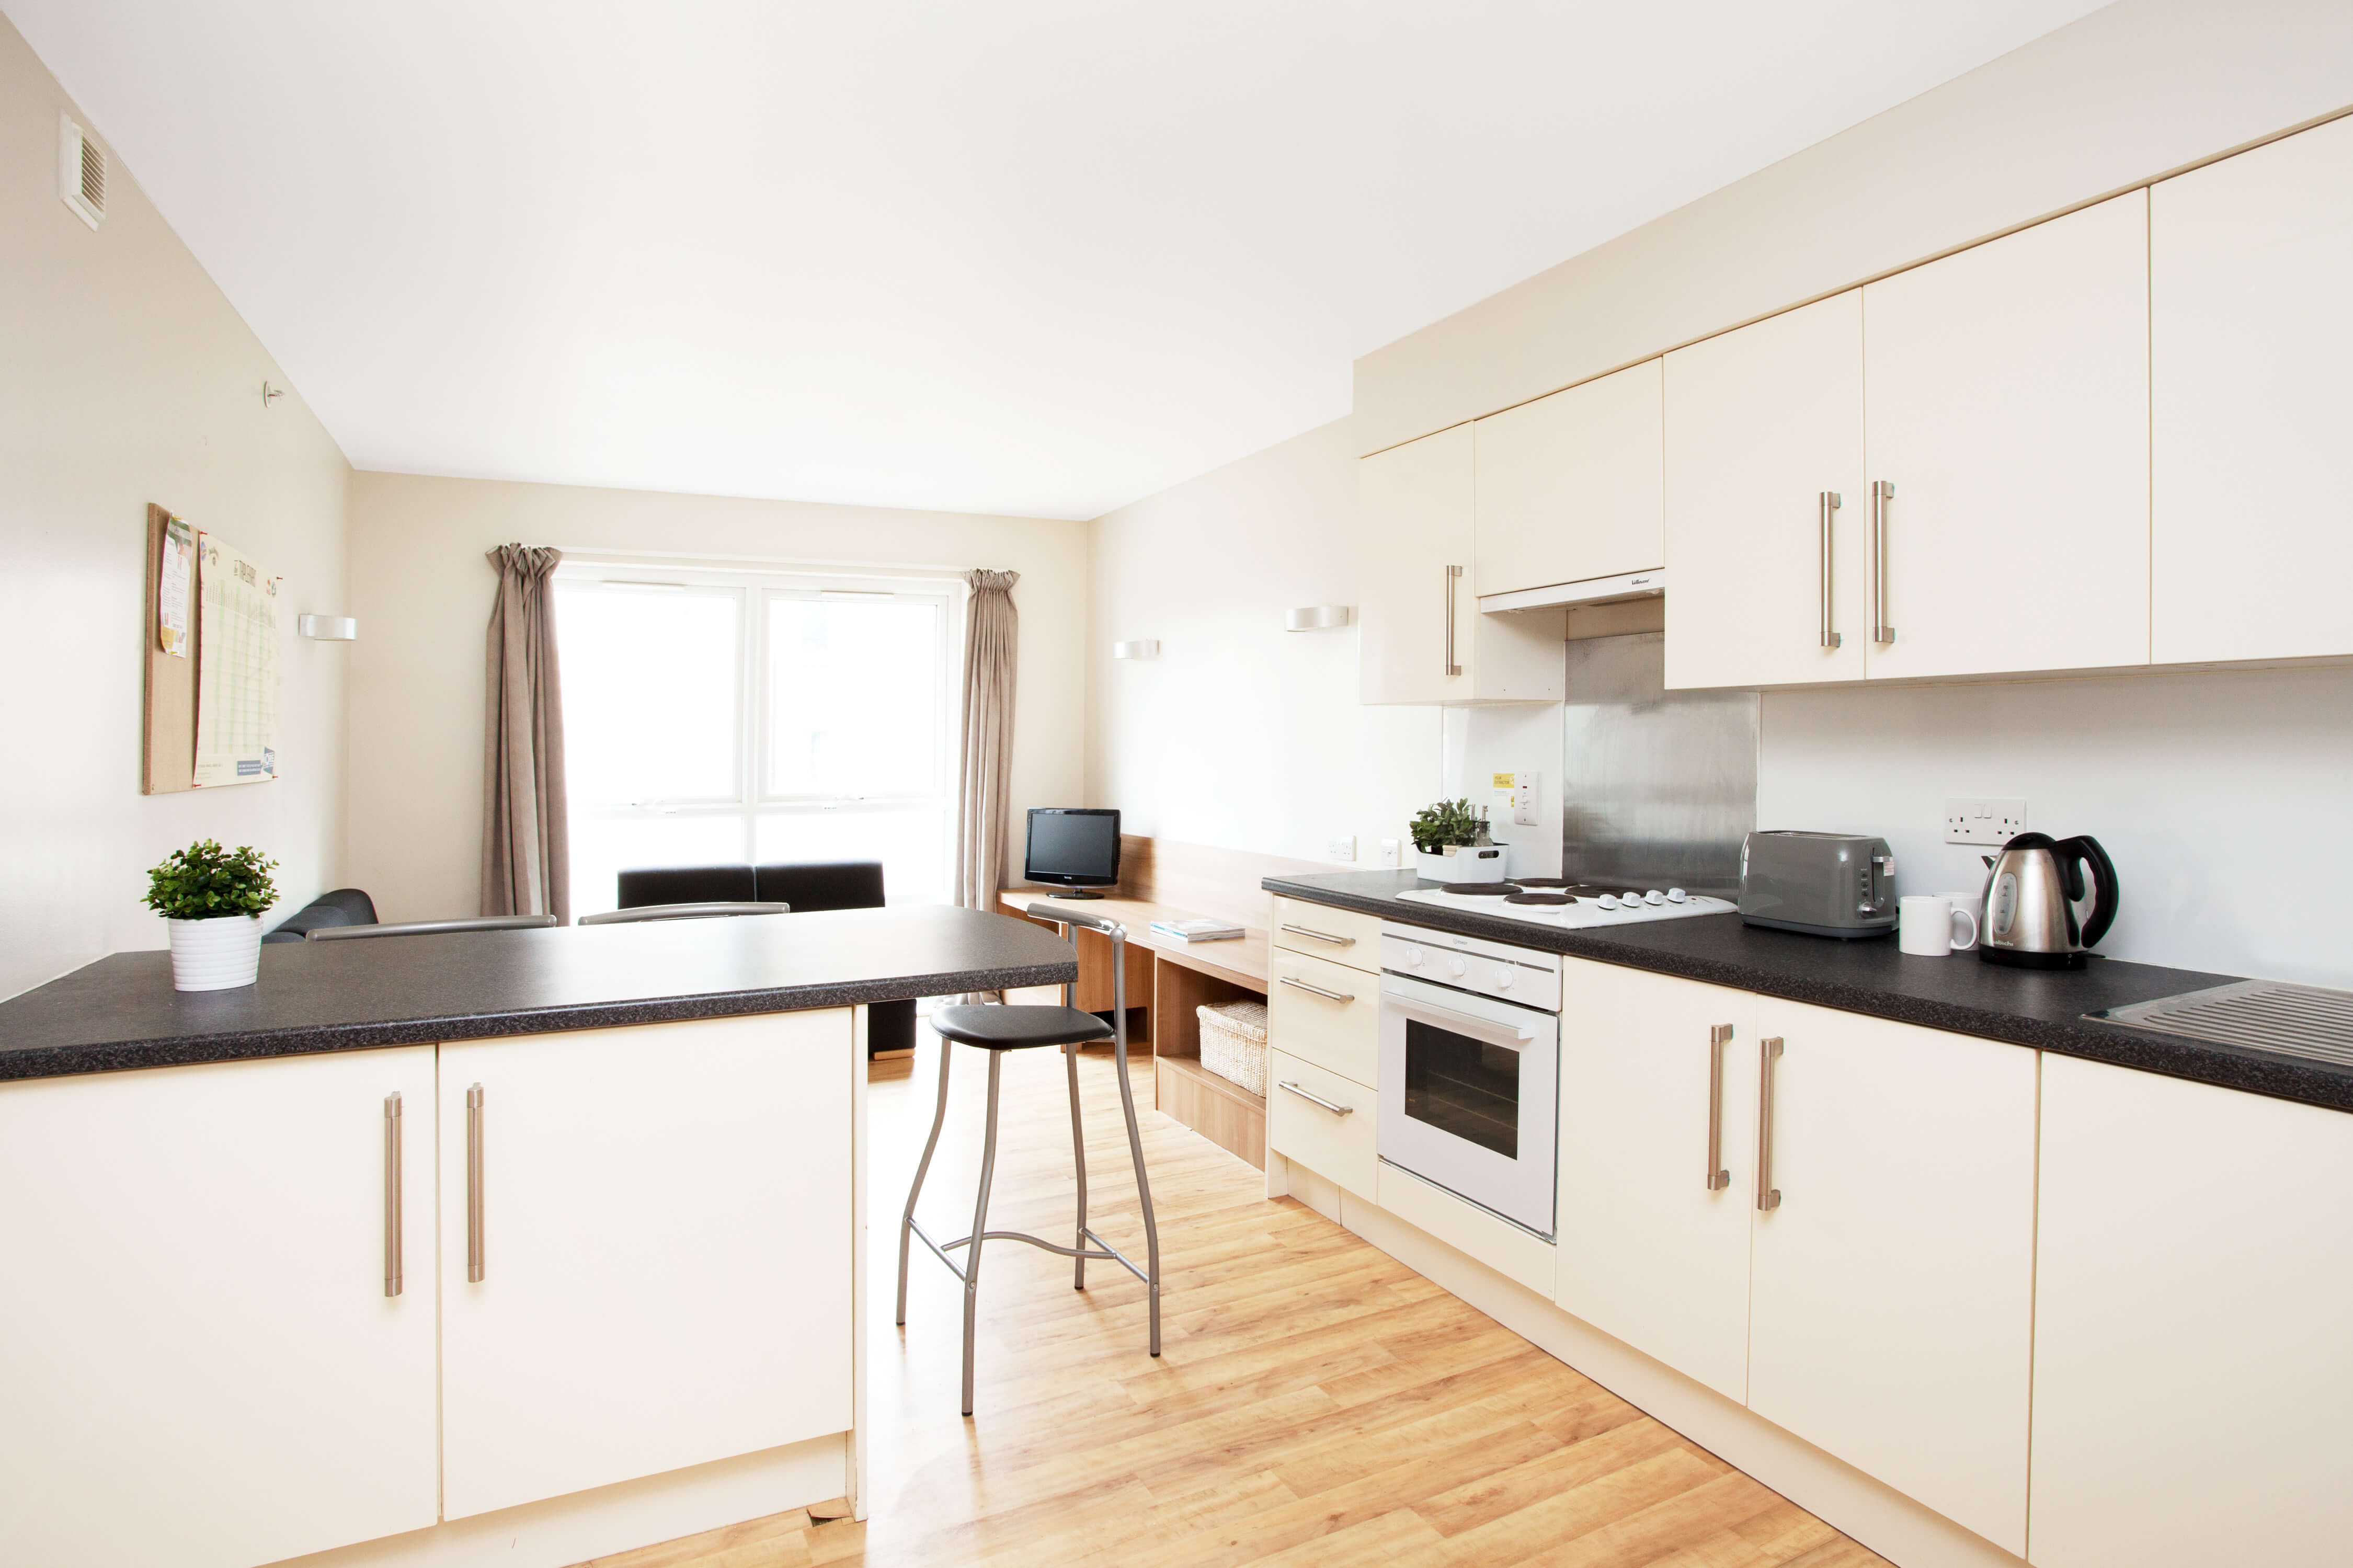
[483,544,572,925]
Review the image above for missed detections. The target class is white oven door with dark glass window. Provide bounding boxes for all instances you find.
[1379,975,1560,1239]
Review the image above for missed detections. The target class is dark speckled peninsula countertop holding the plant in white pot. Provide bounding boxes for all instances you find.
[0,907,1078,1081]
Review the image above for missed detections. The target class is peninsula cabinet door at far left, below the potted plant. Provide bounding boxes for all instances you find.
[0,1045,438,1568]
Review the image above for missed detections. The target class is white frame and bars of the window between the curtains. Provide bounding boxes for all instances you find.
[553,551,972,902]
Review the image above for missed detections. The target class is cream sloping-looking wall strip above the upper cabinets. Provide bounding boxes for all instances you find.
[1355,0,2353,452]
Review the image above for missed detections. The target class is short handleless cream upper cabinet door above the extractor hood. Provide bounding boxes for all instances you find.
[1471,360,1666,593]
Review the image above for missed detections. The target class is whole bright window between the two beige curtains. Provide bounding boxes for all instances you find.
[555,560,963,913]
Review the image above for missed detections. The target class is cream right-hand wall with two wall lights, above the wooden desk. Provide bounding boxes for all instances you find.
[1087,419,1438,869]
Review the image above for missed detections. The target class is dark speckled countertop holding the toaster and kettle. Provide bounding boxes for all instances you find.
[1261,871,2353,1111]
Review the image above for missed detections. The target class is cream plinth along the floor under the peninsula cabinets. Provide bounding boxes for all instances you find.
[276,1432,850,1568]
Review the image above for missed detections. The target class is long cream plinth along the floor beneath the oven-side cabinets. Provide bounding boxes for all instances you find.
[1266,1153,2026,1568]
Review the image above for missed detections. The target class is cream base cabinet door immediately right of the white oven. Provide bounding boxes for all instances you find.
[1558,960,1755,1401]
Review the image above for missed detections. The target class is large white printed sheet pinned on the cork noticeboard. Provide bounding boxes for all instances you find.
[196,530,282,789]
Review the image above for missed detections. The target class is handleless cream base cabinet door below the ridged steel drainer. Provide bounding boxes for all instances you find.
[2028,1057,2353,1568]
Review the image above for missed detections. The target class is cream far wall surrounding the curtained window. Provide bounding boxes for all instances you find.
[348,473,1087,921]
